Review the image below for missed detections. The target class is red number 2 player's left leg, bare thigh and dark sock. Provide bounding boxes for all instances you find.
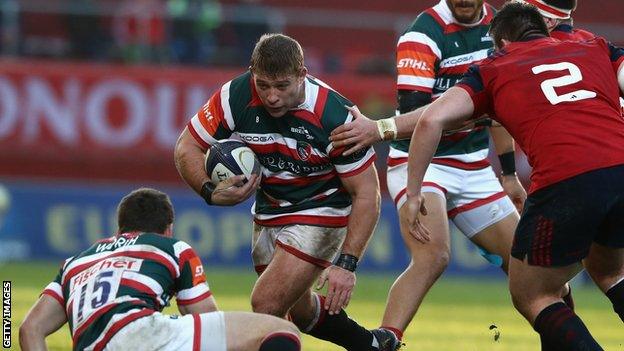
[509,257,602,350]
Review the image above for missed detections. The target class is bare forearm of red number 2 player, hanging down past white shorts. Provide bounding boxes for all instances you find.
[407,118,443,196]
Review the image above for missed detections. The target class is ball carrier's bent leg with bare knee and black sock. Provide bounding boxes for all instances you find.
[251,246,374,351]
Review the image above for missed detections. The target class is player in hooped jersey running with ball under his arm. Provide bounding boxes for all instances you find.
[175,34,398,351]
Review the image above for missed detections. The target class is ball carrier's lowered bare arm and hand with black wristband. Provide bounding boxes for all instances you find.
[318,164,381,313]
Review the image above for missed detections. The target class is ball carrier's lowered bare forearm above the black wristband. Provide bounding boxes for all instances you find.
[342,184,381,258]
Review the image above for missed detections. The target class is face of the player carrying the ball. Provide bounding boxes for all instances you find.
[253,69,306,118]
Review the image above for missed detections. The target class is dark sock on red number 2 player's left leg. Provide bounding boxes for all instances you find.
[533,302,602,351]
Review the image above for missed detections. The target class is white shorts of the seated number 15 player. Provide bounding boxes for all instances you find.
[104,312,227,351]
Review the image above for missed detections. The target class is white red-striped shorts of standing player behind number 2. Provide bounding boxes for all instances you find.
[387,162,516,238]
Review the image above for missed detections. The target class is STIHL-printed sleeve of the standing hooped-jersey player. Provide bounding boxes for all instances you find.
[396,13,442,94]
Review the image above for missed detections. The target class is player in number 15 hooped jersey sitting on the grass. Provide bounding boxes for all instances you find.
[19,188,301,351]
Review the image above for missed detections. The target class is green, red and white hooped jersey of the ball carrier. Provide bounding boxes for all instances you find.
[187,72,375,227]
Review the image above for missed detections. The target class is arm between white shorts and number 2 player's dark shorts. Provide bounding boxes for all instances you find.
[490,123,527,212]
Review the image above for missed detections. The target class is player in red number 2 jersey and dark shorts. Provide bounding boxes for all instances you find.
[405,2,624,350]
